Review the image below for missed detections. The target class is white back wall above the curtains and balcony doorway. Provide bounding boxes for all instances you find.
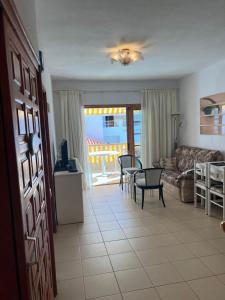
[53,80,178,145]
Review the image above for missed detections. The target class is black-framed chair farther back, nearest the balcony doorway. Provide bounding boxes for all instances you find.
[118,154,142,190]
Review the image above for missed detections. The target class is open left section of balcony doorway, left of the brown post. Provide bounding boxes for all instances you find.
[85,107,127,185]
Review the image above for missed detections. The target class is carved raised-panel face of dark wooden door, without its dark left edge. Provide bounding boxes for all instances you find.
[5,13,54,300]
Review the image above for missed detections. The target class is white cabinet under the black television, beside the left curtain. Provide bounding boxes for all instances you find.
[55,171,84,225]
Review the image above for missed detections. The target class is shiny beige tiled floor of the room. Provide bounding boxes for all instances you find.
[55,185,225,300]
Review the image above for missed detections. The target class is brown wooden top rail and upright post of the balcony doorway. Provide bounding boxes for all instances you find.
[84,103,141,155]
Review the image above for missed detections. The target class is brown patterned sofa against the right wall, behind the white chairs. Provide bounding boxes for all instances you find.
[153,146,223,202]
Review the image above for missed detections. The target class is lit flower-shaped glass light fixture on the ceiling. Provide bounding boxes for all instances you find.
[106,43,144,66]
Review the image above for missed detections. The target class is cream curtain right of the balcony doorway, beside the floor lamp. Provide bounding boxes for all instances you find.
[142,89,177,167]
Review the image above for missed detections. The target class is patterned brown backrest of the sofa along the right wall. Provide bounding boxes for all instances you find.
[175,146,223,172]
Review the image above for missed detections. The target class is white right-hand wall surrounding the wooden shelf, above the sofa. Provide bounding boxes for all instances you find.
[179,60,225,152]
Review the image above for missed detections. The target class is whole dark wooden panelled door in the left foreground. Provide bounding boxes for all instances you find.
[1,4,54,300]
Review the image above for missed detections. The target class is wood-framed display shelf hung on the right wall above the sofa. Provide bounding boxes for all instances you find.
[200,93,225,135]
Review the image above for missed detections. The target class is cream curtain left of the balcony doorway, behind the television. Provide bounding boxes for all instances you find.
[59,90,92,189]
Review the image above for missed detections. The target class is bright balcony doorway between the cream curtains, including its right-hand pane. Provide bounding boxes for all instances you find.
[85,105,141,186]
